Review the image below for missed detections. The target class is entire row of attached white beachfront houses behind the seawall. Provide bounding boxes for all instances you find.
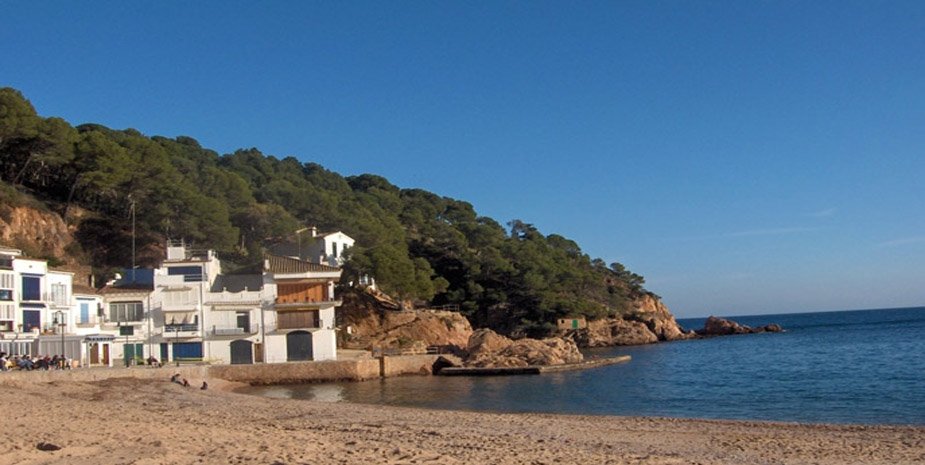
[0,242,342,366]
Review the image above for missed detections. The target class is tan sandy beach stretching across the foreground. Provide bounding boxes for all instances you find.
[0,374,925,465]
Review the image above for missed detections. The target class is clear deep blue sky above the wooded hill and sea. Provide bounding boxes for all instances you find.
[0,0,925,316]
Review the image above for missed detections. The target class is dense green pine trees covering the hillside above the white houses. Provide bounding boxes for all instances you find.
[0,88,646,335]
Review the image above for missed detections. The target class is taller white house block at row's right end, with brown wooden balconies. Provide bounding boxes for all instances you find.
[151,243,341,364]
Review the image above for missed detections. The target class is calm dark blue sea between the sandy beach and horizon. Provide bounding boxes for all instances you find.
[248,307,925,425]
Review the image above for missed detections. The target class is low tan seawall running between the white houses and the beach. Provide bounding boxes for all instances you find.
[0,355,450,387]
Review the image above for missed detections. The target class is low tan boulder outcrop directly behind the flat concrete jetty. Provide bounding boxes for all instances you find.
[465,329,584,368]
